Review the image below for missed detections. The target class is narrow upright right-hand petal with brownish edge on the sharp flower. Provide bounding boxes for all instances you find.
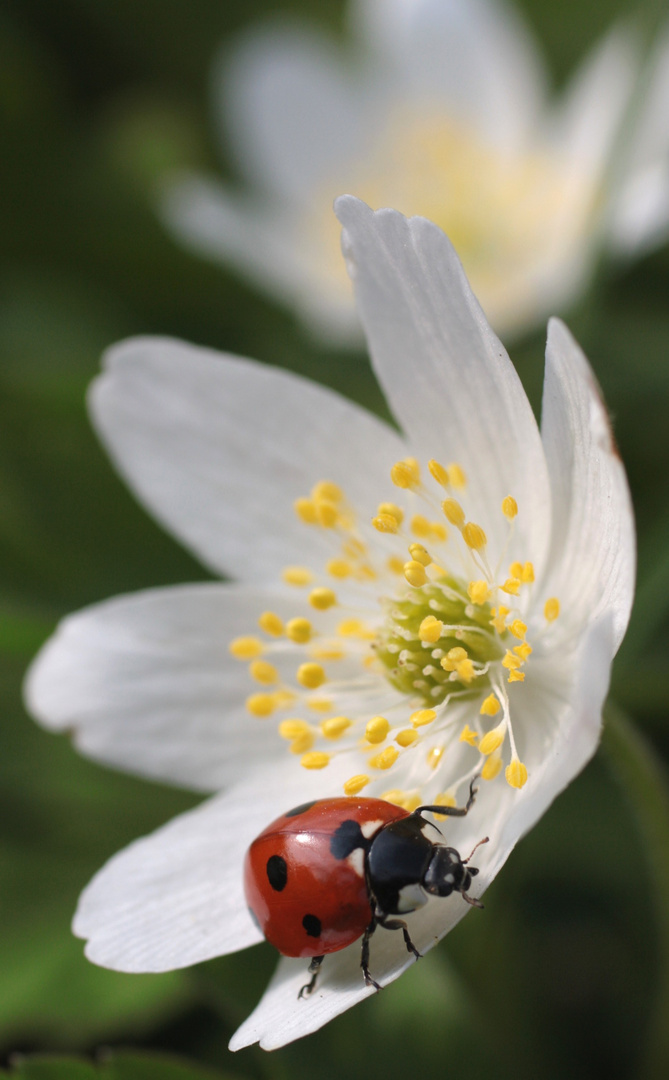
[541,319,635,648]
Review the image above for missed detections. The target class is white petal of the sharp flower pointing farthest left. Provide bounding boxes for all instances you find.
[25,584,324,792]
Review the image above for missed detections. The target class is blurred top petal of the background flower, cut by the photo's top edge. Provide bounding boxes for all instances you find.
[351,0,545,148]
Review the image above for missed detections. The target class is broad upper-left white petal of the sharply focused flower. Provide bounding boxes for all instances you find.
[90,338,405,583]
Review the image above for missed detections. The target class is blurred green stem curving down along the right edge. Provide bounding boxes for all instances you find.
[602,702,669,1080]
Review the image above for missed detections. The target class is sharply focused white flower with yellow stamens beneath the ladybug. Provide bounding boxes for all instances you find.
[27,195,634,1049]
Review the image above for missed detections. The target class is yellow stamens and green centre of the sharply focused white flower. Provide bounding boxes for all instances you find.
[230,458,560,808]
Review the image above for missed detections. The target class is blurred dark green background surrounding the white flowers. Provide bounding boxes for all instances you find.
[0,0,669,1080]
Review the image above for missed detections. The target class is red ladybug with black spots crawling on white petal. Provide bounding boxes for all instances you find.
[244,781,487,998]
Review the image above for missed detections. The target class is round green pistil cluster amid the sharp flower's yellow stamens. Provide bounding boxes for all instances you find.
[375,577,507,705]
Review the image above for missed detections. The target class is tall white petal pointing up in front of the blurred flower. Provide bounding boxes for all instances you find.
[335,195,550,566]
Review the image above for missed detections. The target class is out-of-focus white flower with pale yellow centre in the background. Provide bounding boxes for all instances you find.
[163,0,669,342]
